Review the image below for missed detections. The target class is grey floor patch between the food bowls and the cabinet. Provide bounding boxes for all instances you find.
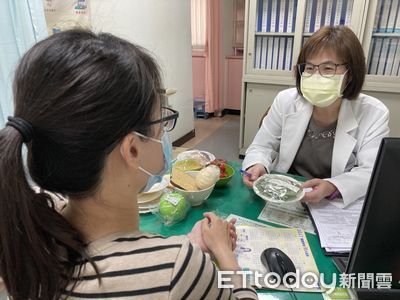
[192,116,242,162]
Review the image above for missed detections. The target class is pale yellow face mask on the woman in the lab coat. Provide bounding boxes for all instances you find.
[300,73,346,107]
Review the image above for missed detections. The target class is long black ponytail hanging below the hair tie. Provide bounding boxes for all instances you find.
[0,127,95,299]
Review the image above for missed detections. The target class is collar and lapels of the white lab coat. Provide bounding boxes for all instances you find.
[279,95,358,177]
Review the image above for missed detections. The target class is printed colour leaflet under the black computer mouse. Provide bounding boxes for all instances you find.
[235,226,321,292]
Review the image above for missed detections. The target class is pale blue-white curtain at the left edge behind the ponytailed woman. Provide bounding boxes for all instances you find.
[0,0,47,128]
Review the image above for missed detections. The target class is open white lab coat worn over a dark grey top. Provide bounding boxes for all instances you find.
[243,88,389,207]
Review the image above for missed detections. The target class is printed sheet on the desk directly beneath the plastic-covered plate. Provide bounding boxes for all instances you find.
[258,202,315,234]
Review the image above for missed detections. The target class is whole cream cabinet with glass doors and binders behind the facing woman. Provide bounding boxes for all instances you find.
[239,0,400,154]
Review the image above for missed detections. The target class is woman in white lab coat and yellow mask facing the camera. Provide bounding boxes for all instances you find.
[243,26,389,207]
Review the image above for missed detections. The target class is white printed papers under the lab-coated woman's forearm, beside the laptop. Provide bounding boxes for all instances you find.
[308,200,364,252]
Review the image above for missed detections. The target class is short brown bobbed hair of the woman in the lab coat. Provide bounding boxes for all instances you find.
[295,26,367,100]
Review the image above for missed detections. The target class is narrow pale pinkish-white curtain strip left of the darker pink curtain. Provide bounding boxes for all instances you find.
[191,0,206,49]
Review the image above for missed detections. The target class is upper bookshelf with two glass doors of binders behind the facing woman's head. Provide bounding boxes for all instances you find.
[245,0,362,77]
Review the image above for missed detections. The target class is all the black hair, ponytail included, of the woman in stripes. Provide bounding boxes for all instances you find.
[0,30,161,300]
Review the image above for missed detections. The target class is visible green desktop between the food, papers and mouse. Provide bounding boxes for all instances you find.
[140,163,339,300]
